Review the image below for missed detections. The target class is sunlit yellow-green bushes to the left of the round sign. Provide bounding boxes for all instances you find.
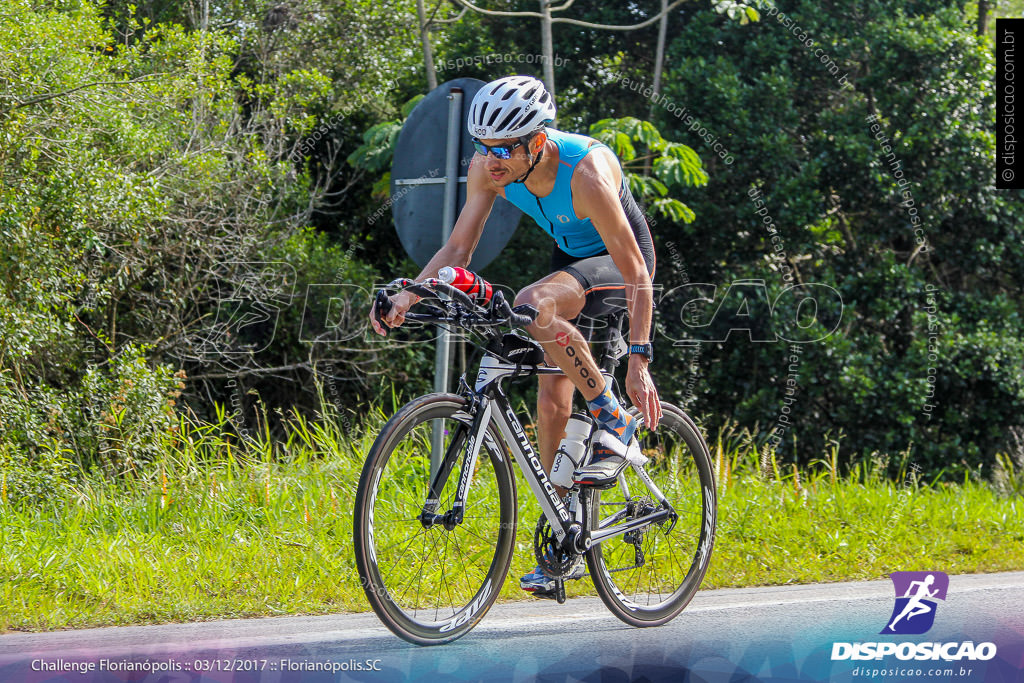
[0,2,419,485]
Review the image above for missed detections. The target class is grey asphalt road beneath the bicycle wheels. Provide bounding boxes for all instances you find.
[0,572,1024,683]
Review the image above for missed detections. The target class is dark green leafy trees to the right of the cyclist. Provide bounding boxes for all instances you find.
[647,2,1024,472]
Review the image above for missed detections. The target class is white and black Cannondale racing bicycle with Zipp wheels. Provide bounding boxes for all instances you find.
[354,279,717,645]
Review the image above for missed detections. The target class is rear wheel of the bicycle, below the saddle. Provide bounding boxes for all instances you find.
[587,402,718,627]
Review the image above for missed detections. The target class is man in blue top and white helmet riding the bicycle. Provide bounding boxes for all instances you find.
[370,76,662,597]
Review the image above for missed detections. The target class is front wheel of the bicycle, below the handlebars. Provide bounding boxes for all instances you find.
[354,393,516,645]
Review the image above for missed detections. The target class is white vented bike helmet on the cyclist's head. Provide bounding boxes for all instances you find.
[466,76,555,139]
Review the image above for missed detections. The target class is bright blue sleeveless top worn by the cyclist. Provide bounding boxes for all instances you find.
[505,128,610,258]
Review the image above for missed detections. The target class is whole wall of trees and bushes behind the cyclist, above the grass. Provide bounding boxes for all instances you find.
[0,0,1024,507]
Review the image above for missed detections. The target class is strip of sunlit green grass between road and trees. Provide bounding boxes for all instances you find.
[0,409,1024,632]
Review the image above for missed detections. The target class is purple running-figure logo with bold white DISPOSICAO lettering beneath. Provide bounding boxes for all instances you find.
[831,571,995,661]
